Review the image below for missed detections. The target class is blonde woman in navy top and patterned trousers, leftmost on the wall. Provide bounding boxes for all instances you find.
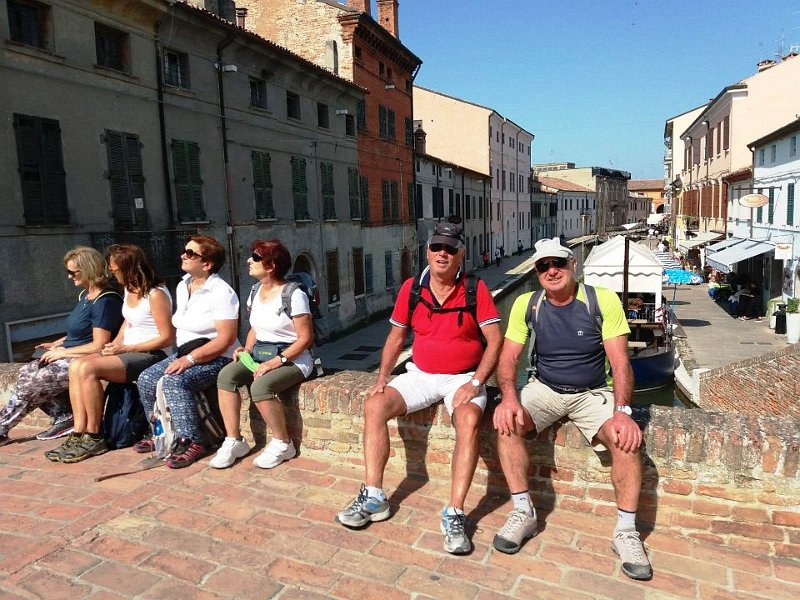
[0,246,122,448]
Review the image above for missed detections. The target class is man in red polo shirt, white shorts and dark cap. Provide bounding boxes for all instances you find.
[336,222,503,554]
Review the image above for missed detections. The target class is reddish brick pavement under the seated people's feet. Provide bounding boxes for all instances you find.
[0,430,800,600]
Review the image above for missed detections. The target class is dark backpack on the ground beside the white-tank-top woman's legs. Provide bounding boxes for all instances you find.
[103,383,150,450]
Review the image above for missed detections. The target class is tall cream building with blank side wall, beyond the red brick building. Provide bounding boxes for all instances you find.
[414,86,535,254]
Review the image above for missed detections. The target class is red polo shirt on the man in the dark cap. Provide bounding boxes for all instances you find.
[389,269,500,374]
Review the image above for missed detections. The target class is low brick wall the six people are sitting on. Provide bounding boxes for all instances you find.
[0,365,800,559]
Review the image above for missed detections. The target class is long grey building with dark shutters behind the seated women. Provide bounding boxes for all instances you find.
[0,0,364,359]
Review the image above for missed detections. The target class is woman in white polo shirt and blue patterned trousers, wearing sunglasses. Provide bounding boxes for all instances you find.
[134,235,239,469]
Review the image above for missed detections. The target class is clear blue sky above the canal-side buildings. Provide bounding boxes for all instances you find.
[399,0,800,179]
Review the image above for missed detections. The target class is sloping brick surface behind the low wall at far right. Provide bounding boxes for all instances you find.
[697,344,800,419]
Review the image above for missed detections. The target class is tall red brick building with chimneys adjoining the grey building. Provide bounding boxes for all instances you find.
[237,0,422,314]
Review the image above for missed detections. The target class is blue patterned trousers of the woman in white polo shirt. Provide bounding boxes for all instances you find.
[136,354,231,444]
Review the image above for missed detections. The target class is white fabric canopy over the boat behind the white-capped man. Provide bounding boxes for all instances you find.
[583,235,664,311]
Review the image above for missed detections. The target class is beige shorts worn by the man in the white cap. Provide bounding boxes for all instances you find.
[519,379,614,450]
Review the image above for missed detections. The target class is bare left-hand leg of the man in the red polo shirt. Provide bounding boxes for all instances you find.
[364,386,407,488]
